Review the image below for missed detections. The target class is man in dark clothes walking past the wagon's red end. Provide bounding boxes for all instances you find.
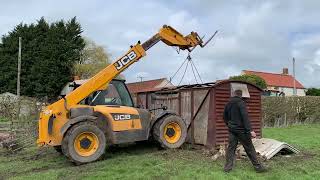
[223,90,266,172]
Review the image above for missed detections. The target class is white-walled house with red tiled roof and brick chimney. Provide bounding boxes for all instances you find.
[242,68,306,96]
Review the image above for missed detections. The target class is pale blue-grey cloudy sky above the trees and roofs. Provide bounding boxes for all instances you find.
[0,0,320,87]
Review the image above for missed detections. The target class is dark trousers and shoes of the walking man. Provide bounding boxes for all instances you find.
[224,130,261,171]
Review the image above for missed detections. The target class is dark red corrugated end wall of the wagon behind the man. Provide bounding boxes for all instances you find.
[214,83,262,145]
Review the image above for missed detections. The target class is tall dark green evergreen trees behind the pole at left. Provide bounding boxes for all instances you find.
[0,17,85,99]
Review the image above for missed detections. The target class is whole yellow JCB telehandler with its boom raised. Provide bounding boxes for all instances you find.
[37,25,212,164]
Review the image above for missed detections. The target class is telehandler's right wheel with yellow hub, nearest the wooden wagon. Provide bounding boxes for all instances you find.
[153,115,187,149]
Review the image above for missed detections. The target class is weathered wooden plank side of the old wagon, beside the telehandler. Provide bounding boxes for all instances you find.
[139,88,209,145]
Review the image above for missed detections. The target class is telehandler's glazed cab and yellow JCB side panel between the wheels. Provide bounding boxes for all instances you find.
[90,80,149,144]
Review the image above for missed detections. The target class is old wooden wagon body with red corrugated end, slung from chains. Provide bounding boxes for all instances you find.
[131,80,262,147]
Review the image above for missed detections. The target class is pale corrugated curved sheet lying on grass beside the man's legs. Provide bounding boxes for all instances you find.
[240,138,300,160]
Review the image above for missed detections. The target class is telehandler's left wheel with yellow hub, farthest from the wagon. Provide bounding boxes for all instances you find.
[62,122,106,165]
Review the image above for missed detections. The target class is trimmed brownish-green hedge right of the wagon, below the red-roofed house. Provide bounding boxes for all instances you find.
[262,96,320,127]
